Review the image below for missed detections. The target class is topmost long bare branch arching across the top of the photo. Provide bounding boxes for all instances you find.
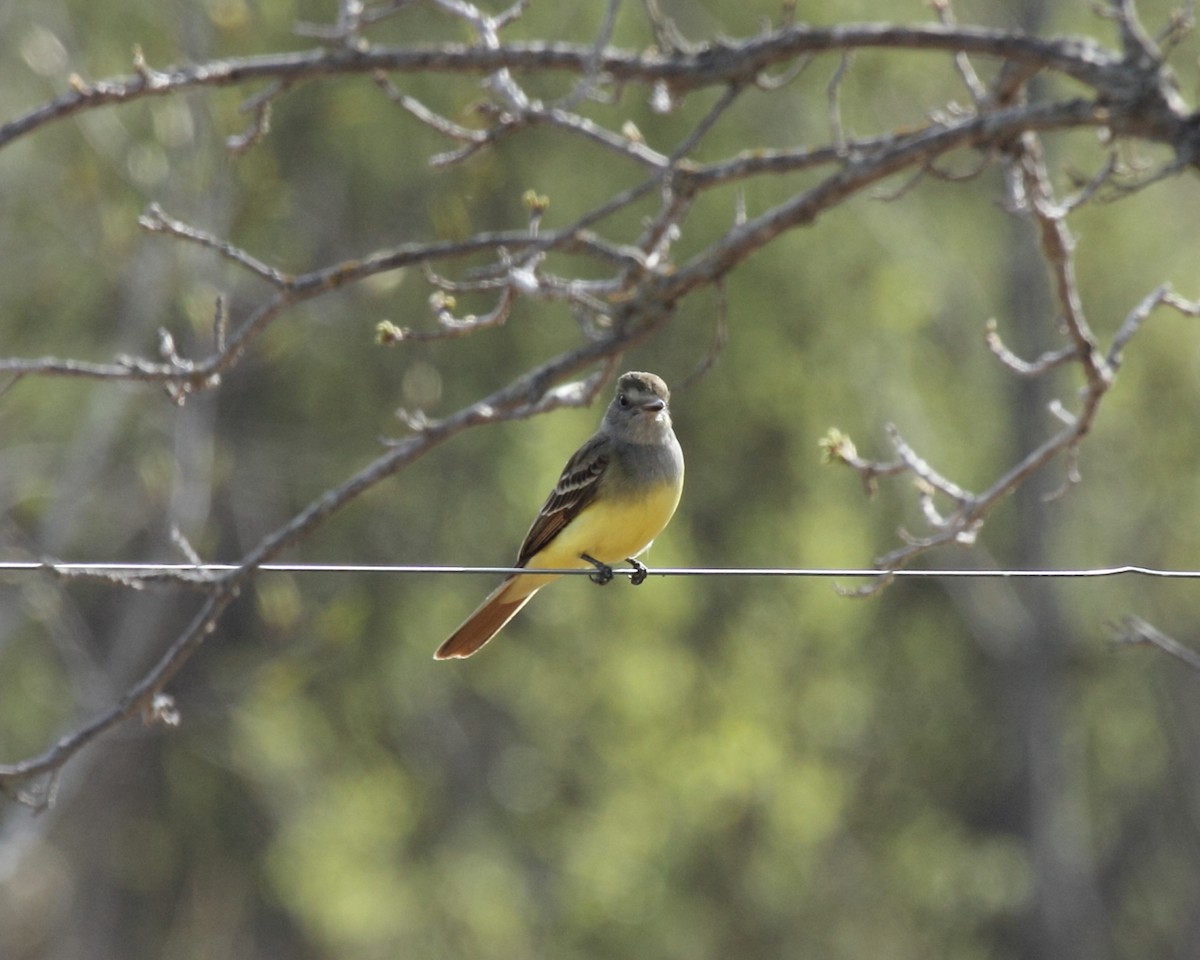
[7,23,1171,148]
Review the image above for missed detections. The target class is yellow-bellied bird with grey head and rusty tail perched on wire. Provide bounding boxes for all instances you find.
[433,371,684,660]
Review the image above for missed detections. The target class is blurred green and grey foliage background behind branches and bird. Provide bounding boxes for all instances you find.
[0,0,1200,960]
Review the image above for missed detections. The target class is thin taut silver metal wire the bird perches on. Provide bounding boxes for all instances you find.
[0,560,1200,580]
